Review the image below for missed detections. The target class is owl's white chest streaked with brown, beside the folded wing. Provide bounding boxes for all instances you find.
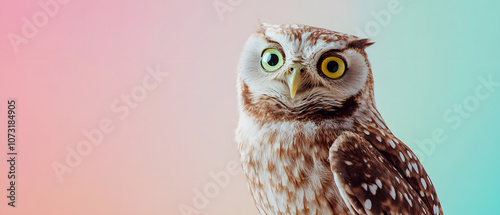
[239,121,346,214]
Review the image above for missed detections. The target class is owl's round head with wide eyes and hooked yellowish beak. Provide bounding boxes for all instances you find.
[238,22,373,120]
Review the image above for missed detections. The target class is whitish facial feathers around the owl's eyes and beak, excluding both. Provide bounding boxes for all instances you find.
[239,23,369,106]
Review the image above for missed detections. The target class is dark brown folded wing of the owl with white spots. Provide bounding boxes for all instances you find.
[329,132,440,215]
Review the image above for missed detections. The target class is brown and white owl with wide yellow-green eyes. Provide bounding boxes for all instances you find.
[236,22,443,215]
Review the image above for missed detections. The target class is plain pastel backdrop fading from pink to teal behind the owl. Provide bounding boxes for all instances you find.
[0,0,500,215]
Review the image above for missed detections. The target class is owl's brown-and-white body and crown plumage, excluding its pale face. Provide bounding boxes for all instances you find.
[236,23,443,214]
